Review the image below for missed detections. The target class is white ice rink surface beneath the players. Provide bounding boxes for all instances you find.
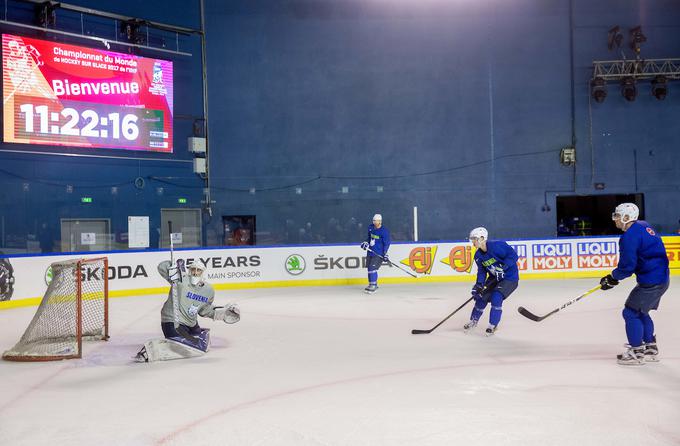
[0,278,680,446]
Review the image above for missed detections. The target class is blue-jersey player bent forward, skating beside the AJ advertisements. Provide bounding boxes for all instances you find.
[463,228,519,336]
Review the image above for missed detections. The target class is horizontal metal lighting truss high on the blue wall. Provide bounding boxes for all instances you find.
[593,59,680,81]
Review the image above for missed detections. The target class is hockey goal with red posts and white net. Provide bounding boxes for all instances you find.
[2,257,109,361]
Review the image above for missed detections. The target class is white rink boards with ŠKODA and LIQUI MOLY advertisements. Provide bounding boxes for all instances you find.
[0,236,680,309]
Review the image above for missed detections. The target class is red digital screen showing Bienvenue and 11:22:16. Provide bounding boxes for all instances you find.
[2,34,173,153]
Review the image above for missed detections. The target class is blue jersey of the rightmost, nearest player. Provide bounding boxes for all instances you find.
[612,220,669,285]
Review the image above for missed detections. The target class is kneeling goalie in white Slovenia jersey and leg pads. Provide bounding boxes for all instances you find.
[135,261,241,362]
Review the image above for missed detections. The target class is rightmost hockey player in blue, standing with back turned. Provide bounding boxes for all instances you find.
[600,203,670,365]
